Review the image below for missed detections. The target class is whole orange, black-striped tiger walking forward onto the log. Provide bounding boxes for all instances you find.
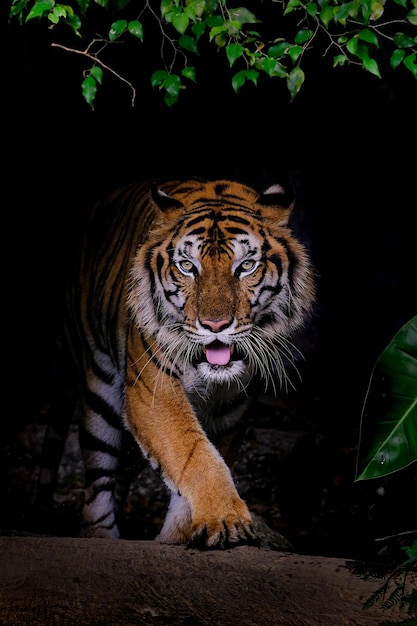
[65,178,315,548]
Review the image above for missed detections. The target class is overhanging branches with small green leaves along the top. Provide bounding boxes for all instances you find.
[10,0,417,108]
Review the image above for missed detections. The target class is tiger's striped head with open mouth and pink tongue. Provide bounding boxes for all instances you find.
[128,180,314,385]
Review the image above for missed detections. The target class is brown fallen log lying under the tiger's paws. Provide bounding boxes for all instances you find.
[0,537,417,626]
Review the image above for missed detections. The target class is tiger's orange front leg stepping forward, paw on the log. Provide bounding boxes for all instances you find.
[126,376,256,548]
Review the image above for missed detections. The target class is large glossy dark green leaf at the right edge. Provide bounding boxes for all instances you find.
[356,316,417,480]
